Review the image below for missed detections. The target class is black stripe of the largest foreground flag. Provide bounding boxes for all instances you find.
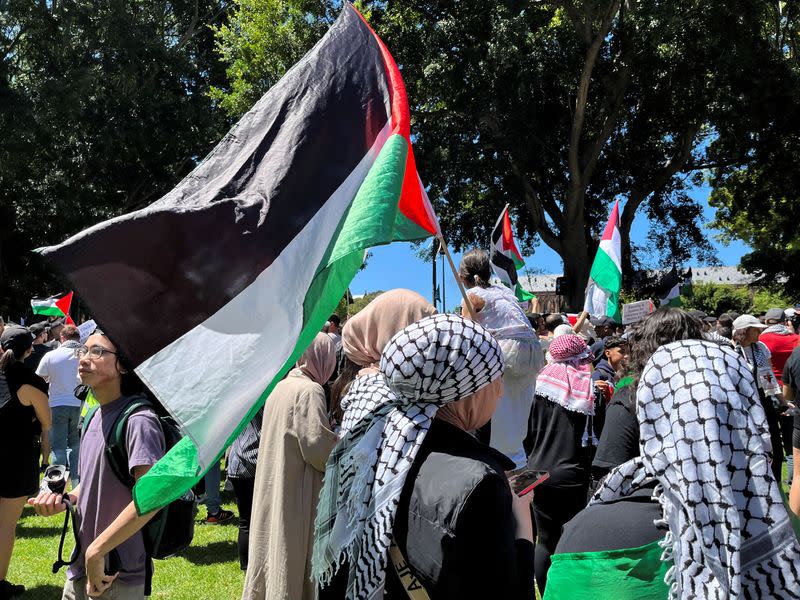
[43,10,390,364]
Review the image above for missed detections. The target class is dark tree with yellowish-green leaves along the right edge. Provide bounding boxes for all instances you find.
[710,2,800,296]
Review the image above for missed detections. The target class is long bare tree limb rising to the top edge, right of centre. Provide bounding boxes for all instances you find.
[566,0,620,221]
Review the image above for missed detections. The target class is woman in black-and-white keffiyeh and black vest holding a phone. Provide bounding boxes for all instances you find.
[312,315,534,600]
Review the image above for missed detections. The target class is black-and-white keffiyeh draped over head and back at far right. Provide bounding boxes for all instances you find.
[592,340,800,600]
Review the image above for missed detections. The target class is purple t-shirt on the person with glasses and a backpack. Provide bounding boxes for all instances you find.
[67,396,164,585]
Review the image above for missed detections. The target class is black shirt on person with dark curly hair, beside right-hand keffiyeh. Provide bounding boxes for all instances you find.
[592,384,639,477]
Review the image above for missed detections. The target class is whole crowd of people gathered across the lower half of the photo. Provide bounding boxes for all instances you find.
[0,250,800,600]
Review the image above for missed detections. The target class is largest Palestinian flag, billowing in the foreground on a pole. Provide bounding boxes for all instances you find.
[37,4,438,514]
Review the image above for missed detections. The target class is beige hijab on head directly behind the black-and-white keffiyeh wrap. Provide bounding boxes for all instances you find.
[342,289,436,375]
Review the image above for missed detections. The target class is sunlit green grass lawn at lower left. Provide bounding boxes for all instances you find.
[8,492,244,600]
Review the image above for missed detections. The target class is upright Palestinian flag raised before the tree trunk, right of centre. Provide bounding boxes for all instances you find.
[583,202,622,323]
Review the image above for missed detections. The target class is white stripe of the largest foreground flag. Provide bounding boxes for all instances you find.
[136,121,391,469]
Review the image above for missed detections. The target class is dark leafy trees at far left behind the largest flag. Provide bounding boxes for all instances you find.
[0,0,228,317]
